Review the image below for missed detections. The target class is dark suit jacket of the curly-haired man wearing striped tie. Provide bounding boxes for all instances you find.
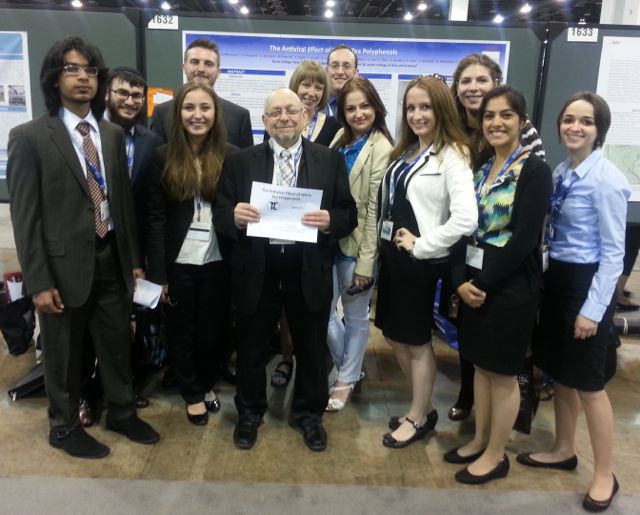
[7,114,141,307]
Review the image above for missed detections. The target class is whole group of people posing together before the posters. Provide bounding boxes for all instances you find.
[8,34,630,511]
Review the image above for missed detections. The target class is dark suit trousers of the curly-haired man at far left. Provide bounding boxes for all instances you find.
[40,231,135,431]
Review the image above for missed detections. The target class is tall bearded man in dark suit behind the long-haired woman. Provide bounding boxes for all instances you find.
[151,38,253,148]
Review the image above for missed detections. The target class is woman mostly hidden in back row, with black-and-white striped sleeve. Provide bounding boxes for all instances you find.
[449,54,545,420]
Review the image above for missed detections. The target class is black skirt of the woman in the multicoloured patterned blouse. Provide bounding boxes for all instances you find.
[458,245,541,375]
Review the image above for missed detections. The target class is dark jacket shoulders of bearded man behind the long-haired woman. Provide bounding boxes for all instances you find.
[150,97,253,148]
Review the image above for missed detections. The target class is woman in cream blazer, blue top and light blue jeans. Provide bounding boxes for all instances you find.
[327,77,393,411]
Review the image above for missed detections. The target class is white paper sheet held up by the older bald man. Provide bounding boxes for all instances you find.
[247,182,322,243]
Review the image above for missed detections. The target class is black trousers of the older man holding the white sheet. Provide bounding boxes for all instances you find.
[235,244,331,426]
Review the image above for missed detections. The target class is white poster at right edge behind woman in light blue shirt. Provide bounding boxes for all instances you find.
[597,36,640,202]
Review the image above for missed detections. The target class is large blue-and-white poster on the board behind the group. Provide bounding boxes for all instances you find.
[182,31,509,143]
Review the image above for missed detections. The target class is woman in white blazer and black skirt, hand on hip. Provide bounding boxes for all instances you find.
[375,77,478,448]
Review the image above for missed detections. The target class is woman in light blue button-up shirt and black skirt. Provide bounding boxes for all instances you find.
[517,92,631,511]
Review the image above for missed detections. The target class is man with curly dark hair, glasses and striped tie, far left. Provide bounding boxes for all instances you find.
[7,37,159,458]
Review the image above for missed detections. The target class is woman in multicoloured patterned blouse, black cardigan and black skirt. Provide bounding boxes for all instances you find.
[444,86,552,484]
